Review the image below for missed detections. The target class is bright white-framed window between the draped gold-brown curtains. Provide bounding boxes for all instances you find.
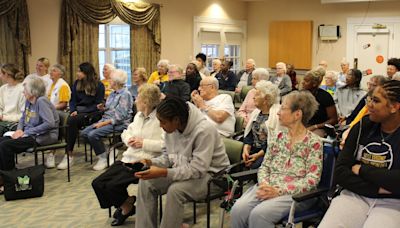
[99,23,131,86]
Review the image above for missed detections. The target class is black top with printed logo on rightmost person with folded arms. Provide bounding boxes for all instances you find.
[335,116,400,198]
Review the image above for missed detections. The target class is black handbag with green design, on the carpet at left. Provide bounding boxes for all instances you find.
[0,165,45,201]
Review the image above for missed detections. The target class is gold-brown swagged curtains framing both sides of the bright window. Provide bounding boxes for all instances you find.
[60,0,161,83]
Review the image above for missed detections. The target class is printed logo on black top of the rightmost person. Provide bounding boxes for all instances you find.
[357,142,393,169]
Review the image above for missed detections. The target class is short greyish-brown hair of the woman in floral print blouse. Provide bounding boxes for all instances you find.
[283,90,319,125]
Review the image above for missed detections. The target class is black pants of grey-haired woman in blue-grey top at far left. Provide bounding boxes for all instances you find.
[0,136,35,170]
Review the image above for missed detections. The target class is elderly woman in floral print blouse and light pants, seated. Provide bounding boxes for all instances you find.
[231,91,323,228]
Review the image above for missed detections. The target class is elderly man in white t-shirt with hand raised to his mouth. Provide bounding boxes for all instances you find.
[191,77,235,136]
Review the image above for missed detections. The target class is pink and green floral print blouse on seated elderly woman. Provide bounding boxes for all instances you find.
[258,130,323,195]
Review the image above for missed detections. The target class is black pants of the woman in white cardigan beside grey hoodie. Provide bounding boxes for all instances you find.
[92,161,138,208]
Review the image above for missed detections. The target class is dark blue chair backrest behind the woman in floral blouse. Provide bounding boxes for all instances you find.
[319,144,336,189]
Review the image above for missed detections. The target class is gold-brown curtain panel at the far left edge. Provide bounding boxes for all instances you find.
[0,0,31,74]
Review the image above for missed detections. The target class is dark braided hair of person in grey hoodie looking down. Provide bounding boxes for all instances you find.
[157,96,189,125]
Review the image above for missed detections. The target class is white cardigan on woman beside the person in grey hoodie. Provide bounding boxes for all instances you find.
[121,110,164,163]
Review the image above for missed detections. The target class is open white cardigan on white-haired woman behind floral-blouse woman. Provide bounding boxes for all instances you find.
[244,104,282,144]
